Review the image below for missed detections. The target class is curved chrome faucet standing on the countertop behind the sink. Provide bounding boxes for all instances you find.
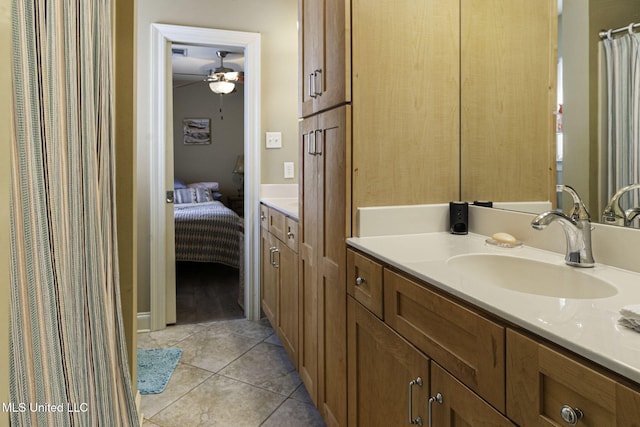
[531,185,595,267]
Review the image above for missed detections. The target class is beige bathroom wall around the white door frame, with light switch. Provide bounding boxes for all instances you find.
[136,0,298,312]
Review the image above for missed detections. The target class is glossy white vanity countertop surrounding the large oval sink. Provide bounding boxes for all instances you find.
[347,232,640,383]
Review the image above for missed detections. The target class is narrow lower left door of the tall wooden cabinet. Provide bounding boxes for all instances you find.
[298,113,318,405]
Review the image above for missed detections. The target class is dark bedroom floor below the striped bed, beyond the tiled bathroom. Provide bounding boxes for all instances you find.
[176,261,244,325]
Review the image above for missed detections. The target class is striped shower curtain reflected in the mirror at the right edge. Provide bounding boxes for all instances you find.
[603,32,640,208]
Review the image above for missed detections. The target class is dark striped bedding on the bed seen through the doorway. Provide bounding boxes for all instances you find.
[173,201,242,268]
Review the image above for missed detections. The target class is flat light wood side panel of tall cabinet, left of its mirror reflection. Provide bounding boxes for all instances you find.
[351,0,460,221]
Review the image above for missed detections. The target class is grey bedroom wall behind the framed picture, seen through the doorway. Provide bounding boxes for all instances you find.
[173,82,244,197]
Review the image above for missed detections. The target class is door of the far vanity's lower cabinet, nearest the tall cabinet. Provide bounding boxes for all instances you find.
[276,242,298,369]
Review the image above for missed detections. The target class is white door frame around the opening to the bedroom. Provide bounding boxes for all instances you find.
[149,24,261,331]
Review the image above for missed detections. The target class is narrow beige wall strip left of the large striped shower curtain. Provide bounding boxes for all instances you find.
[0,0,12,427]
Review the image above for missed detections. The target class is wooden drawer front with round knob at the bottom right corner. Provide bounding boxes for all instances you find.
[507,330,640,426]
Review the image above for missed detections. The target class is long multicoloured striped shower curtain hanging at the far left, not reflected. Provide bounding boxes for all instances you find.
[8,0,138,426]
